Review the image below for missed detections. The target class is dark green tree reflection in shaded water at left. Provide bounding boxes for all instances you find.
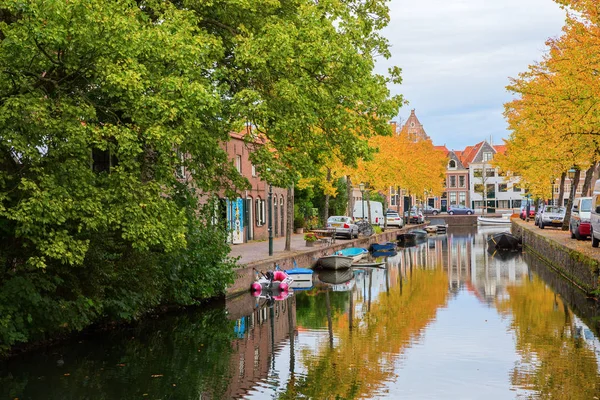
[0,308,234,400]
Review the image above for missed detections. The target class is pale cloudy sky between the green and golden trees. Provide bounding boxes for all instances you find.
[377,0,565,150]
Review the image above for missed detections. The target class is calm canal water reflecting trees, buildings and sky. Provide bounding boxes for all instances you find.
[0,228,600,400]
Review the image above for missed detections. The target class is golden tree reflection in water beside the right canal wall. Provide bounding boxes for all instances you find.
[496,275,600,399]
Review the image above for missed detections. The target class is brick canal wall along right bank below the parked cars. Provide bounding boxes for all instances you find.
[511,218,600,295]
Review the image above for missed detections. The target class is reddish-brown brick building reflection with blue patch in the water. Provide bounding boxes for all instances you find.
[224,296,296,399]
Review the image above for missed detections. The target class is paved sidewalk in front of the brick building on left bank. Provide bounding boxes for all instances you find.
[229,233,314,265]
